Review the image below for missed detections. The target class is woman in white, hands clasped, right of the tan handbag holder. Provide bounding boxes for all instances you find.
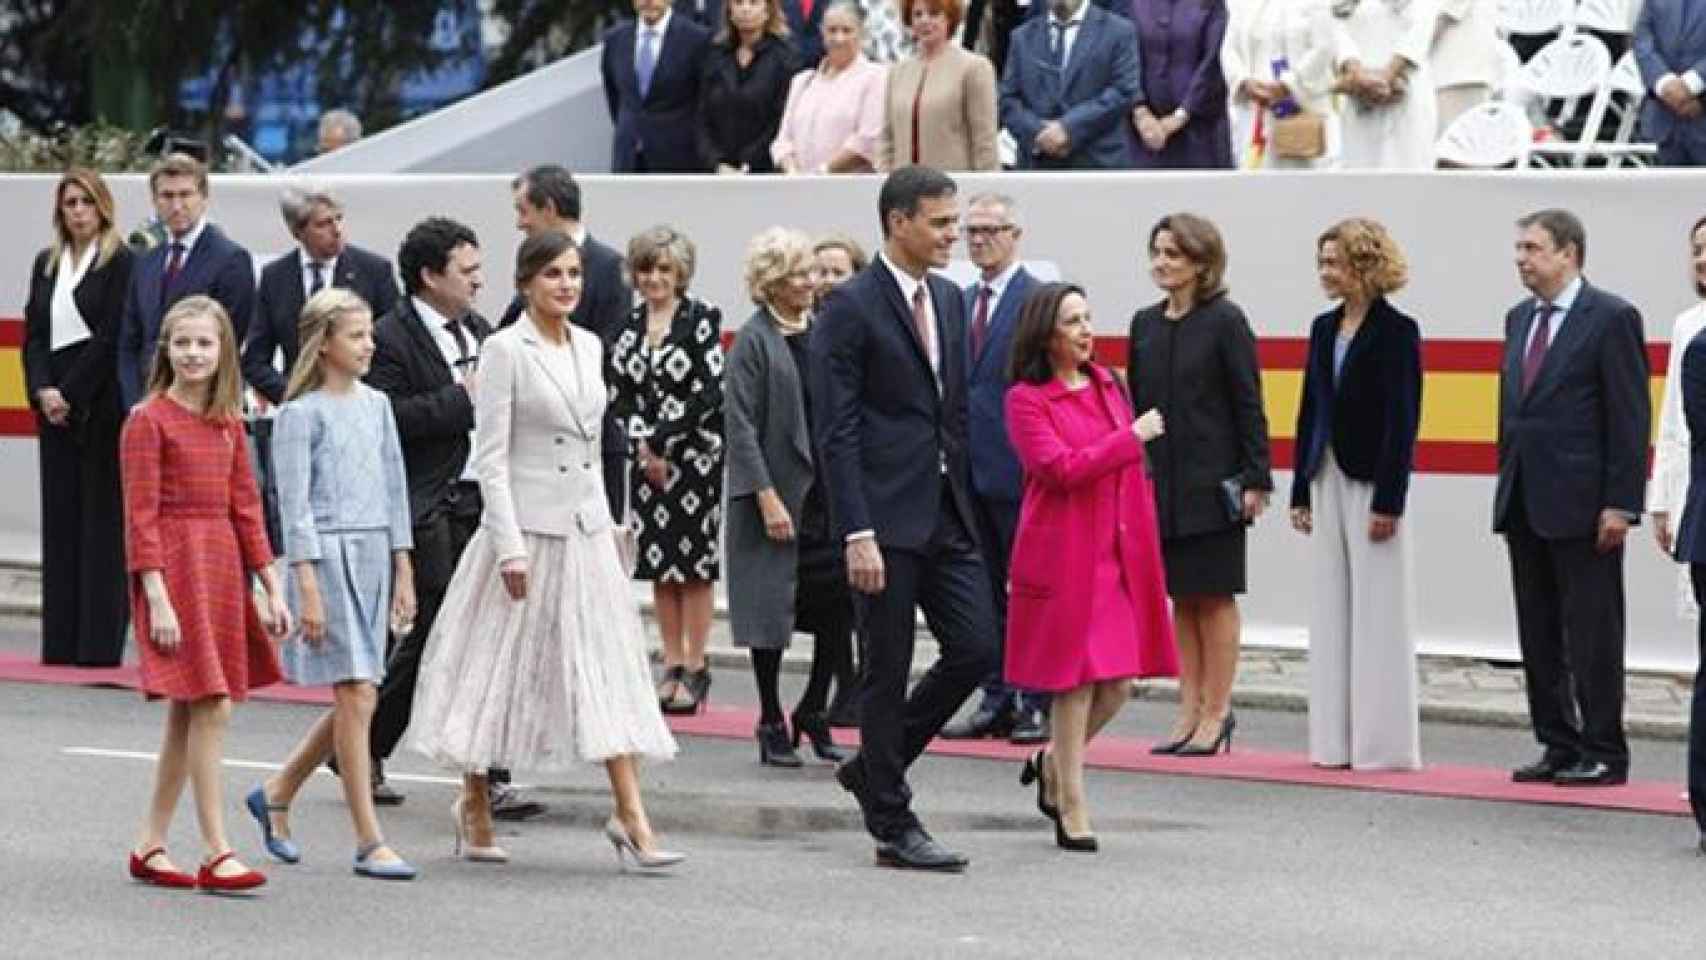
[1329,0,1438,171]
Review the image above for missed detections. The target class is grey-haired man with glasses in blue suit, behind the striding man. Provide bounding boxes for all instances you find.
[942,193,1049,743]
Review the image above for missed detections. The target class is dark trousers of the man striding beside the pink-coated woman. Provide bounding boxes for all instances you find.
[853,486,995,841]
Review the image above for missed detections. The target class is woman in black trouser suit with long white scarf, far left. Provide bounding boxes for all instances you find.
[24,167,131,667]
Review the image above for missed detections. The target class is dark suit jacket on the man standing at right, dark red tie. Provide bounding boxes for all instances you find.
[1493,281,1653,541]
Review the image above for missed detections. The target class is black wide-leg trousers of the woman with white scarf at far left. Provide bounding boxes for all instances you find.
[36,352,130,667]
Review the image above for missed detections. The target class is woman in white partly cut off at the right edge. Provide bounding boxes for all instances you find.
[1646,217,1706,621]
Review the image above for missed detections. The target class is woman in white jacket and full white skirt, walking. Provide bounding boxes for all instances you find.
[409,230,682,868]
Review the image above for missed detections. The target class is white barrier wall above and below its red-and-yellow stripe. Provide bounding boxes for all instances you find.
[0,173,1706,668]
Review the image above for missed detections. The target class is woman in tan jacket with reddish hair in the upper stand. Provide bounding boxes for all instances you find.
[877,0,1001,171]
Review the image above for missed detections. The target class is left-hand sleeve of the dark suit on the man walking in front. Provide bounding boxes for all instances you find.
[812,288,872,539]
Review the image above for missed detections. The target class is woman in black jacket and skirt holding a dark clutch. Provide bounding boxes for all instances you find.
[1126,213,1274,757]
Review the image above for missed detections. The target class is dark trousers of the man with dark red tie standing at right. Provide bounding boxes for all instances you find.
[1505,493,1629,772]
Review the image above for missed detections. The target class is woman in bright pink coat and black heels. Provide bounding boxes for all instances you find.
[1007,283,1179,853]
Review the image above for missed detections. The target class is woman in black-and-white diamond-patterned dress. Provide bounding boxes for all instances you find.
[611,227,723,713]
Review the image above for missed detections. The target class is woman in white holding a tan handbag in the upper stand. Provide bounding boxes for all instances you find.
[1220,0,1339,169]
